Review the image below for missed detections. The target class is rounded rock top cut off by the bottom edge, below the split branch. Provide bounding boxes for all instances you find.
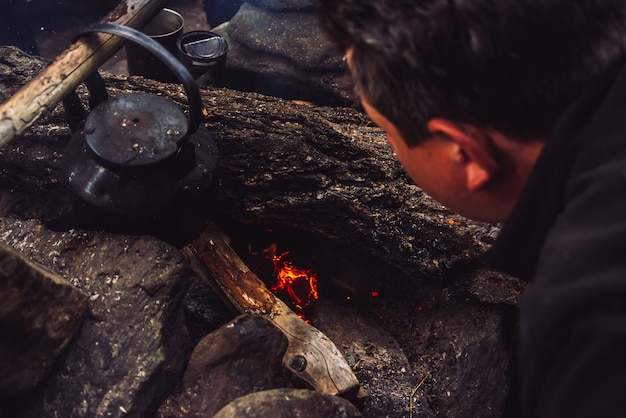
[213,389,363,418]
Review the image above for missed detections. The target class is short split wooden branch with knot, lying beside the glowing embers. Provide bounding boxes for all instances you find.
[181,224,363,398]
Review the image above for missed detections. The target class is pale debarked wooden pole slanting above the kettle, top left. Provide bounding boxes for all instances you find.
[0,0,169,147]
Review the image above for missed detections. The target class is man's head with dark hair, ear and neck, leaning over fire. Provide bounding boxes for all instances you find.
[319,0,626,221]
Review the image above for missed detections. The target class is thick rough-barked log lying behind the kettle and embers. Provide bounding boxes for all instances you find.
[0,47,497,284]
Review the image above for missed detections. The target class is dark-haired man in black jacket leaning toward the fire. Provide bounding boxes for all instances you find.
[319,0,626,418]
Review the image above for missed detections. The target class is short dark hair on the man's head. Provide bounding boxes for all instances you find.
[318,0,626,146]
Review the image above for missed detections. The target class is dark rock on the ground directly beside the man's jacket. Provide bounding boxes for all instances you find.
[375,288,517,418]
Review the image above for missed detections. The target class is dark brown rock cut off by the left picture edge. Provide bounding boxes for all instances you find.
[0,243,87,395]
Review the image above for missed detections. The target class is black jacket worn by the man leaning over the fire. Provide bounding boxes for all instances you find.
[488,60,626,418]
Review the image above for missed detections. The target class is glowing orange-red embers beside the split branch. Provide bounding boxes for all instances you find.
[263,244,319,322]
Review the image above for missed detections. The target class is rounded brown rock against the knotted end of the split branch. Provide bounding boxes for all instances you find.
[178,315,289,417]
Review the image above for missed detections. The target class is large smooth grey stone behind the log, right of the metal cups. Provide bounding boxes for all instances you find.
[214,3,353,105]
